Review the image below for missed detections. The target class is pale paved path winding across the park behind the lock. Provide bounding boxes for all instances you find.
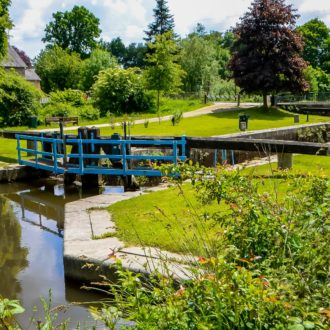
[34,102,260,132]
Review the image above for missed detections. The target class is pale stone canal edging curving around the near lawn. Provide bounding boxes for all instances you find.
[63,186,196,283]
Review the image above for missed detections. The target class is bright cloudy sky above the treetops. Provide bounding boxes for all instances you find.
[10,0,330,58]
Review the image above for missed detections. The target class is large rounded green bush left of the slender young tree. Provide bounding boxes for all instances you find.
[93,67,153,116]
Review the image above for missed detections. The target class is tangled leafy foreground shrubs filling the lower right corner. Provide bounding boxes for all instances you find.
[94,165,330,330]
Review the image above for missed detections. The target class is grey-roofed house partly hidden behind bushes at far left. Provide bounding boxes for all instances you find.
[0,45,41,89]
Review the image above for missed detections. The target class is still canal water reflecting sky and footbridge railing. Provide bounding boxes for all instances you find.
[0,180,118,329]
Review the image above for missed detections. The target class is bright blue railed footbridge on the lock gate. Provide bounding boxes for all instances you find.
[16,134,186,176]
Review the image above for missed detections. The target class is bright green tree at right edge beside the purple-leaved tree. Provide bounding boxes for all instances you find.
[297,18,330,73]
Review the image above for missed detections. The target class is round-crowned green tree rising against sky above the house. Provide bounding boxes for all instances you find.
[42,6,101,57]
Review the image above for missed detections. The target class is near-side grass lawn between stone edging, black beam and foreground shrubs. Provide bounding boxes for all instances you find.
[108,155,330,255]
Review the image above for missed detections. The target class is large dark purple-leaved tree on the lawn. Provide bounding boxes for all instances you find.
[229,0,308,107]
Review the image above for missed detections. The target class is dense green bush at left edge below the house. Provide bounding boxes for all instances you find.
[0,69,42,126]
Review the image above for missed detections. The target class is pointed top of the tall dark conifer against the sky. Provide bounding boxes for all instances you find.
[144,0,174,42]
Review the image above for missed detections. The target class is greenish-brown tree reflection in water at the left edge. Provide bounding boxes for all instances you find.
[0,196,28,299]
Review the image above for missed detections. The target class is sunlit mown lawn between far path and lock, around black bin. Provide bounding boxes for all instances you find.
[101,108,330,136]
